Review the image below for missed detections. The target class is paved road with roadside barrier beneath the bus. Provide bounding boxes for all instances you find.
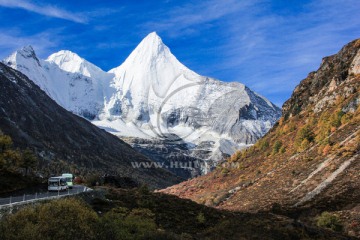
[0,185,89,206]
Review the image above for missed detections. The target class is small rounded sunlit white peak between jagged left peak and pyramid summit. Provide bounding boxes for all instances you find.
[46,50,103,77]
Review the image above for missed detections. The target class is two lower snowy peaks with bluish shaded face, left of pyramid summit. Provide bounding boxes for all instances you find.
[3,46,111,119]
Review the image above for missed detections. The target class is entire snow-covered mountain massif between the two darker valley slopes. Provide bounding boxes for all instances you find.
[3,32,281,175]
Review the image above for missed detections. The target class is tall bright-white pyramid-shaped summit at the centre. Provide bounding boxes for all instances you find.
[109,32,200,101]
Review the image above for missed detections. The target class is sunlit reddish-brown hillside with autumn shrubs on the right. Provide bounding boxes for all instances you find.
[163,40,360,236]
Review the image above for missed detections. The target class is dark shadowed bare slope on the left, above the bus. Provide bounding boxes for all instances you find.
[0,63,180,188]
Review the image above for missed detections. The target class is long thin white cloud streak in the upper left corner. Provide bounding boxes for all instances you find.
[0,0,88,23]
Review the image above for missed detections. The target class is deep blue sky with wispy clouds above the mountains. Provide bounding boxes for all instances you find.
[0,0,360,106]
